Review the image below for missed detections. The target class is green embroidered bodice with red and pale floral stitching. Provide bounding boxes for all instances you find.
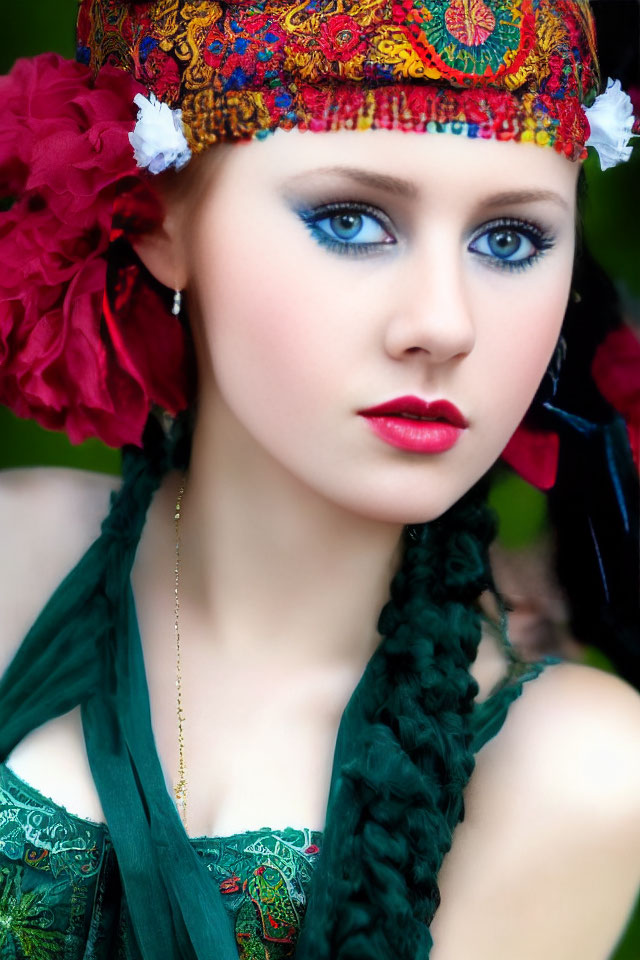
[0,764,322,960]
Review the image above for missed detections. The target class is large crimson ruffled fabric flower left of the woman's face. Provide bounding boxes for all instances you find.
[0,54,190,447]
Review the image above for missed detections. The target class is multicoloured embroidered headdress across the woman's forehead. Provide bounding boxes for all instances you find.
[78,0,600,159]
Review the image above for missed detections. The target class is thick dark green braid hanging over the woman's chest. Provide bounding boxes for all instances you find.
[296,483,495,960]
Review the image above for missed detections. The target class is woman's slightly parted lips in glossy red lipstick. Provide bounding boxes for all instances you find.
[358,396,469,453]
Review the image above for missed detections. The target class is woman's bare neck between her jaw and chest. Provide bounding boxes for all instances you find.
[166,394,402,668]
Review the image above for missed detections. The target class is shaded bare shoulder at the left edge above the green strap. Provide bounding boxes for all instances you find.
[0,467,121,674]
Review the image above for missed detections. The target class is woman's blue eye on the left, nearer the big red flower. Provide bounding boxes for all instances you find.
[299,203,396,256]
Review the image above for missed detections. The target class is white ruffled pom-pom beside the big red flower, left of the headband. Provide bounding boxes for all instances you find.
[129,93,191,173]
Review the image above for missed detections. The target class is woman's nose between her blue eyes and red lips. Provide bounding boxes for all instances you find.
[385,246,476,364]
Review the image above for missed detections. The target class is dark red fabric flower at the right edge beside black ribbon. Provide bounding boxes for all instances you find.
[591,326,640,470]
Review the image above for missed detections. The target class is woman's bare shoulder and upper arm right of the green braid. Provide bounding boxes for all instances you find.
[432,664,640,960]
